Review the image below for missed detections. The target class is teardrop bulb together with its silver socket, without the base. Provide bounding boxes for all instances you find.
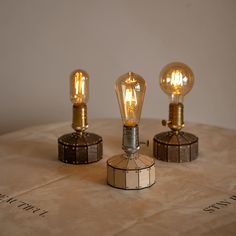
[116,72,146,158]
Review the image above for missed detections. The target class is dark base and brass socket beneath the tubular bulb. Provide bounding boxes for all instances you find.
[58,103,103,165]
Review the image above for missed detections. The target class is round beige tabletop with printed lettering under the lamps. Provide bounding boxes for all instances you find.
[0,119,236,236]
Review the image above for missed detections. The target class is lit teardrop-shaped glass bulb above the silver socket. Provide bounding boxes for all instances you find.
[116,72,146,127]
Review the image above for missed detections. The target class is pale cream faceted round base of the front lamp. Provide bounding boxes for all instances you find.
[107,154,155,190]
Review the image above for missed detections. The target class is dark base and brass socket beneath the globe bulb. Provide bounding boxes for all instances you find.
[153,103,198,162]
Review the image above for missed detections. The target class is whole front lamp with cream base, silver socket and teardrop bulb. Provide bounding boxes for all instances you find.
[107,72,155,189]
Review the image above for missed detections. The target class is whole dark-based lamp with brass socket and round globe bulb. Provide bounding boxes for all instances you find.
[153,62,198,162]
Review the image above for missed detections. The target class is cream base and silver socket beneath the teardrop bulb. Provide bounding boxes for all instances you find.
[107,125,155,190]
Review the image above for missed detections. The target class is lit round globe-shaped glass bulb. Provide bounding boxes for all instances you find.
[160,62,194,103]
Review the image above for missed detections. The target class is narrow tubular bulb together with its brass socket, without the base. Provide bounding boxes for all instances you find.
[70,70,89,134]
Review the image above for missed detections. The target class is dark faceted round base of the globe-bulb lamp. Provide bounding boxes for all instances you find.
[153,131,198,162]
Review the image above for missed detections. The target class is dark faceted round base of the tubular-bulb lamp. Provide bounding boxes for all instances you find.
[58,133,103,165]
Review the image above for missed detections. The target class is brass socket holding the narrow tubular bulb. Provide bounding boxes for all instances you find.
[72,103,88,132]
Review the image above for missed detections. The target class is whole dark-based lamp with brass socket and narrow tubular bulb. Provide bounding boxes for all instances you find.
[58,70,103,165]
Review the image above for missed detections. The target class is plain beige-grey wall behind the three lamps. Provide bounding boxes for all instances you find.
[0,0,236,133]
